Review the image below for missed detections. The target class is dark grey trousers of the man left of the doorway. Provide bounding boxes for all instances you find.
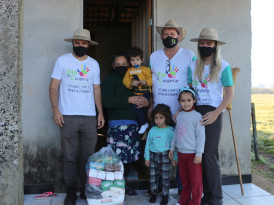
[60,115,97,187]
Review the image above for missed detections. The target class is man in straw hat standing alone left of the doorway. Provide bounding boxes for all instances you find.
[49,29,105,205]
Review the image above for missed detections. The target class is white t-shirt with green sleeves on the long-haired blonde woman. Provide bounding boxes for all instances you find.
[188,60,233,108]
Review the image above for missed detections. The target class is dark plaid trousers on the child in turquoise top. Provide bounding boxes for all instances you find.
[149,151,171,196]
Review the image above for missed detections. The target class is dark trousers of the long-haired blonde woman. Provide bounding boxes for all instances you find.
[196,105,223,205]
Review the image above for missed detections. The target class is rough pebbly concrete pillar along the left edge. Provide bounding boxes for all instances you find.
[0,0,24,205]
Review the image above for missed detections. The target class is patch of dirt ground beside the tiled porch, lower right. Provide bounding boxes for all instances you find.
[251,151,274,195]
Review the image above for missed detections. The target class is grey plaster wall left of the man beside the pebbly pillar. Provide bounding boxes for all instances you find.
[22,0,83,192]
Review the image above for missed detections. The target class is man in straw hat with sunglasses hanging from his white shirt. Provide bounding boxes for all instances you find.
[147,20,196,199]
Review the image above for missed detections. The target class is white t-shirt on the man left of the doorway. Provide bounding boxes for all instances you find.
[51,53,100,116]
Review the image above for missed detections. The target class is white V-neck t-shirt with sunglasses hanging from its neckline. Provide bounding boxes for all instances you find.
[150,48,196,115]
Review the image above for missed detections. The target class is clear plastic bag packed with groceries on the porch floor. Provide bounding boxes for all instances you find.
[85,146,125,199]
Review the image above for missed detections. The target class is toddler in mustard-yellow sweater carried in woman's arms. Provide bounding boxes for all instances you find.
[123,46,152,134]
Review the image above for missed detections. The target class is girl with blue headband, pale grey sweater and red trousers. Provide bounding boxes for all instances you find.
[169,86,205,205]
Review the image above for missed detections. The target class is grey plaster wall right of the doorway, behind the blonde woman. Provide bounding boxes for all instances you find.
[154,0,251,175]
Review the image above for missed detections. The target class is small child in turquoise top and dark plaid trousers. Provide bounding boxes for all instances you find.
[145,104,178,205]
